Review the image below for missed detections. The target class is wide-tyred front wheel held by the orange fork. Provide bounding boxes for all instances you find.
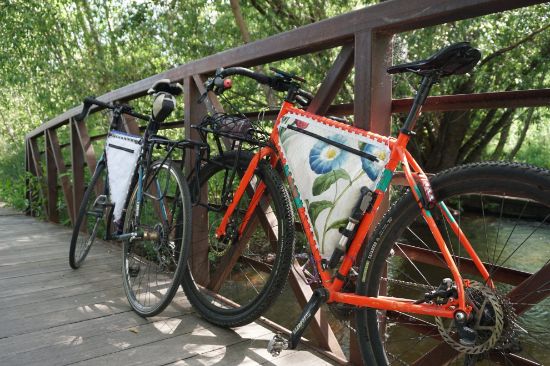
[182,152,294,327]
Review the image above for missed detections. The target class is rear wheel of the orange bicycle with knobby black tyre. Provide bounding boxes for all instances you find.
[356,162,550,365]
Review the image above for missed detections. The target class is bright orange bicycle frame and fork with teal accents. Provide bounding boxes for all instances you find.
[212,101,494,318]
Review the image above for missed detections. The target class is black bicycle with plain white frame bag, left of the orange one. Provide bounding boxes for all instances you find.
[69,80,208,316]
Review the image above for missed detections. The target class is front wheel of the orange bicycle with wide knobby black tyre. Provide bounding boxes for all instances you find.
[182,152,294,327]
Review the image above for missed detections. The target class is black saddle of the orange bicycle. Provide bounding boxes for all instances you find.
[387,42,481,76]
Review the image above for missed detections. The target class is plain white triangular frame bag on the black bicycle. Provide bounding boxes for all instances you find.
[105,131,141,221]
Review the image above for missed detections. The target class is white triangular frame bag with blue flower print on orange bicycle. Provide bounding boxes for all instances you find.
[278,110,390,257]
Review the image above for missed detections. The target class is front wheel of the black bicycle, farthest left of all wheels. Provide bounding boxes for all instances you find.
[69,163,109,269]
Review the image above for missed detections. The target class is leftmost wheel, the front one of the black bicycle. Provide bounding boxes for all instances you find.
[69,164,108,269]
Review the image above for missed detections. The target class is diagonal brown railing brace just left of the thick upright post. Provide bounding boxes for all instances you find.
[307,44,354,115]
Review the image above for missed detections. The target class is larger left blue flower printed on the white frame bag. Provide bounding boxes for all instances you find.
[309,135,348,174]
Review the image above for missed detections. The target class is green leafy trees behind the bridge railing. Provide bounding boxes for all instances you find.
[0,0,550,212]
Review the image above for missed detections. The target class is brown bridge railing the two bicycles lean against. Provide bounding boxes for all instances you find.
[26,0,550,362]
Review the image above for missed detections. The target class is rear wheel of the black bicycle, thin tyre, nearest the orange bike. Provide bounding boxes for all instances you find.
[122,160,191,317]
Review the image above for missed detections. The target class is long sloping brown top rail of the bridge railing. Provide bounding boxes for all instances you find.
[26,0,545,139]
